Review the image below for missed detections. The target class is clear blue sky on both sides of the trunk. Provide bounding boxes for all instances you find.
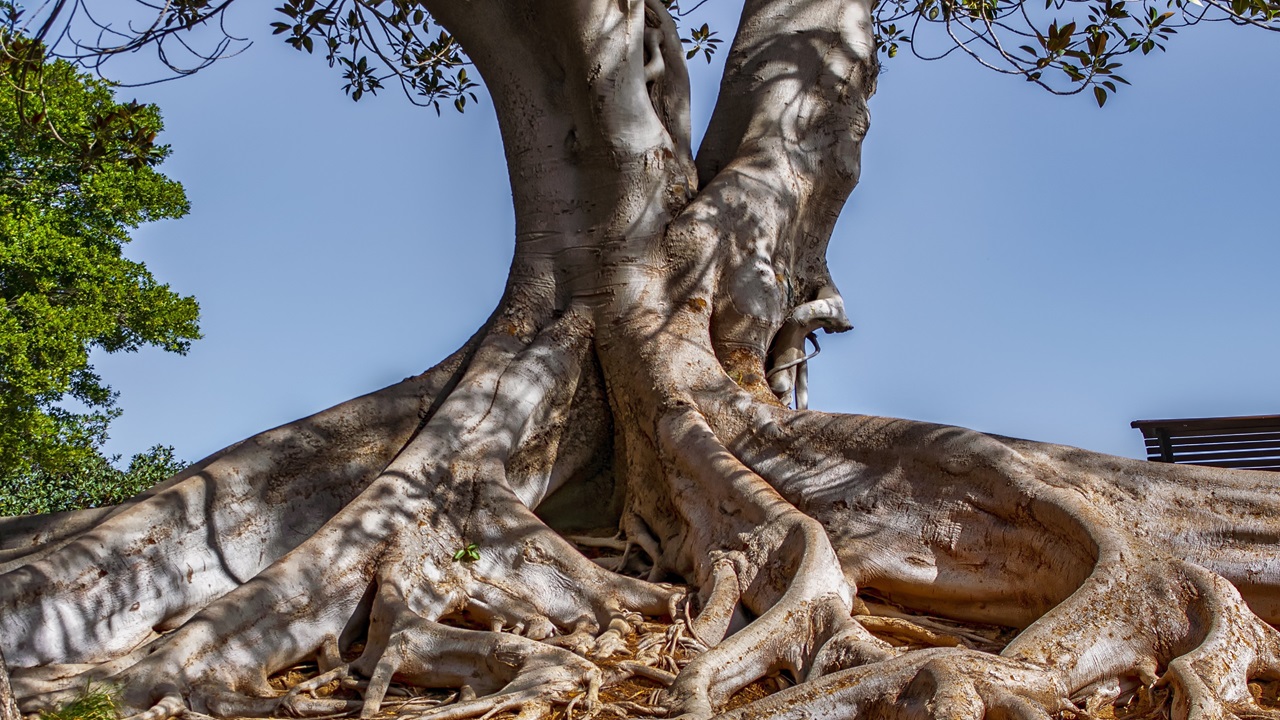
[85,0,1280,460]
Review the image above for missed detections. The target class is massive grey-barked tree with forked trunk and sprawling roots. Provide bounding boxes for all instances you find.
[0,0,1280,720]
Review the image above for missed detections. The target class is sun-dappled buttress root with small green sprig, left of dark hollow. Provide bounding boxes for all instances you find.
[5,314,681,720]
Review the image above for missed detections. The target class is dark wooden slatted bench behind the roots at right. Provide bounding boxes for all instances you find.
[1129,415,1280,471]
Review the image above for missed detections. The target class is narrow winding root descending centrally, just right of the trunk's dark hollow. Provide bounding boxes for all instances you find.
[632,410,892,717]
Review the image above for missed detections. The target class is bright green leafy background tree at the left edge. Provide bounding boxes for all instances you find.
[0,25,200,484]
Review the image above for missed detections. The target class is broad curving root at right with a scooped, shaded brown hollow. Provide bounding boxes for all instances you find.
[696,404,1280,720]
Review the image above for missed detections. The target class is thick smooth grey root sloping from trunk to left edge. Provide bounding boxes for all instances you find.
[0,340,473,667]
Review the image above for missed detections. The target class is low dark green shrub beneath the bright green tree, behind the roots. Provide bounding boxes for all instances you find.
[0,445,186,516]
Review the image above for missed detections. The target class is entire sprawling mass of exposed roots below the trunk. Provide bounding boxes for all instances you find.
[12,240,1280,720]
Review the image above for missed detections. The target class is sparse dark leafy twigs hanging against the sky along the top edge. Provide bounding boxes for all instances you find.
[10,0,1280,111]
